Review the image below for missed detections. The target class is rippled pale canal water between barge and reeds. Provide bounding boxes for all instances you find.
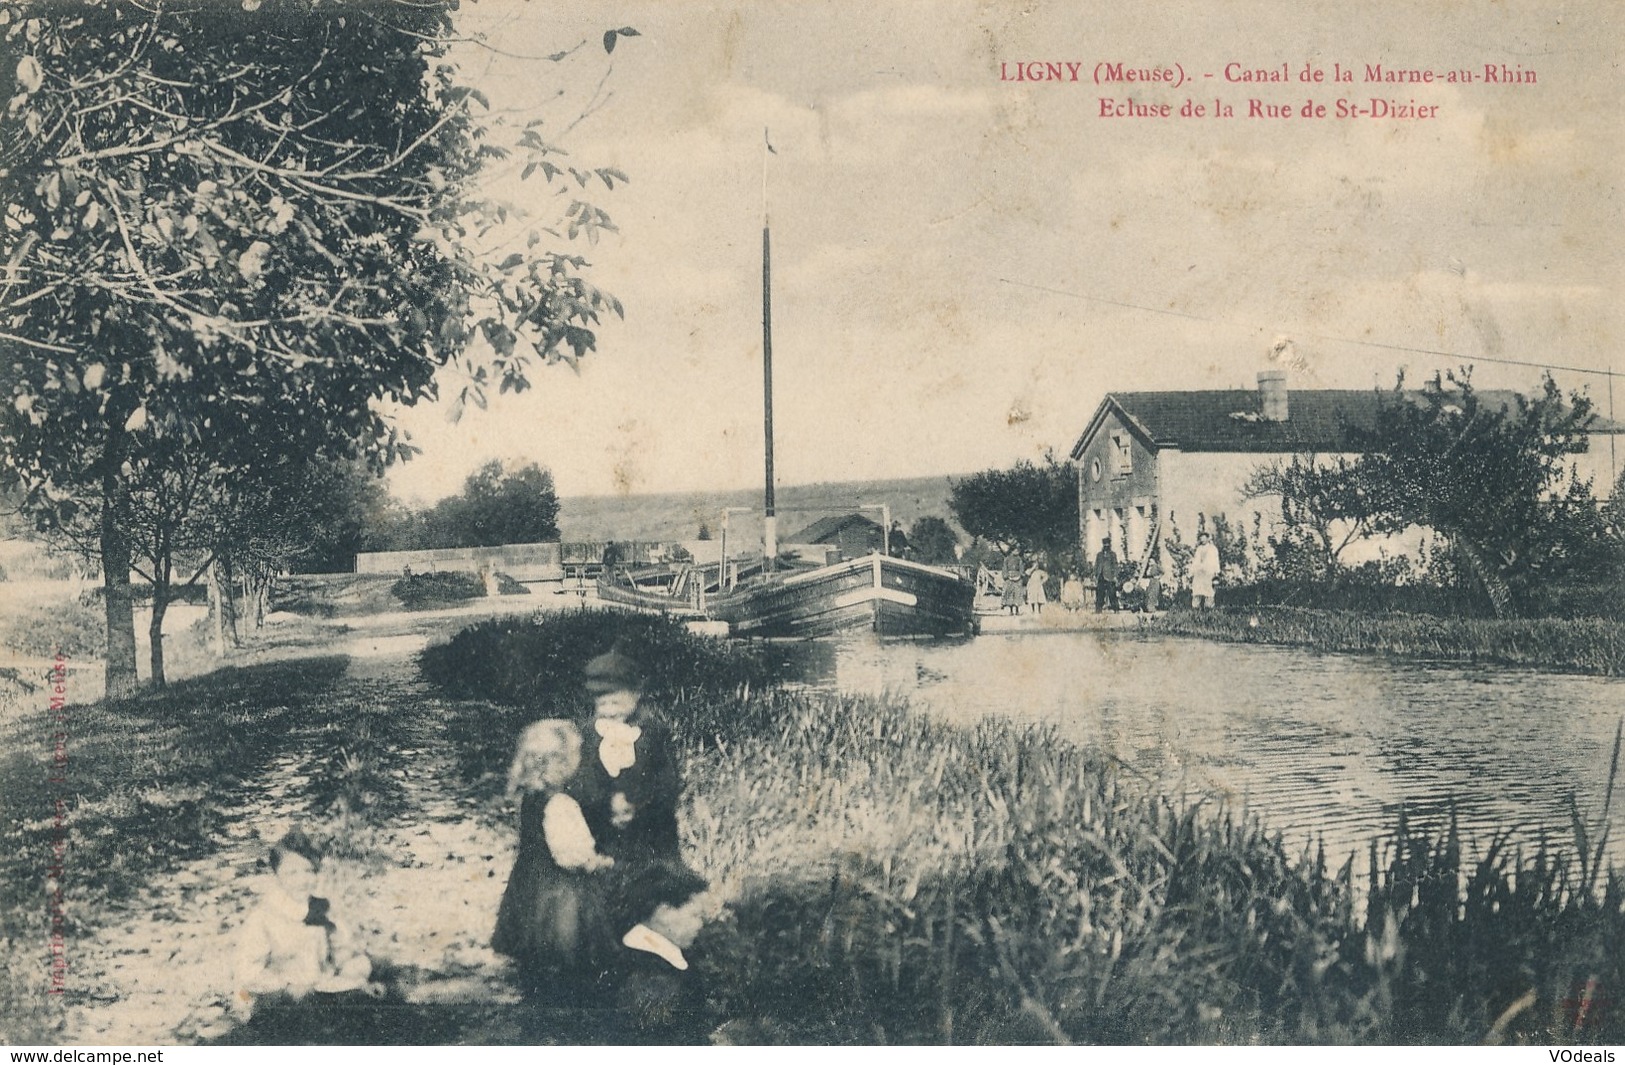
[780,631,1625,870]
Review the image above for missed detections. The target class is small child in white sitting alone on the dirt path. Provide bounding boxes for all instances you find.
[231,829,384,1016]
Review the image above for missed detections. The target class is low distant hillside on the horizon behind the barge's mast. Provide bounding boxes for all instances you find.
[559,475,969,541]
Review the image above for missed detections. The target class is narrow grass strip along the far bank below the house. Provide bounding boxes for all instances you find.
[1147,606,1625,676]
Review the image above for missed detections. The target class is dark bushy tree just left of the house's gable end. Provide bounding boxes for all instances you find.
[947,454,1077,559]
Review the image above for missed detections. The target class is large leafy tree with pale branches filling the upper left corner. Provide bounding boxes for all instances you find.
[0,0,631,694]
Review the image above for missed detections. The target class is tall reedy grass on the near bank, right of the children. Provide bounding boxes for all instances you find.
[426,616,1625,1044]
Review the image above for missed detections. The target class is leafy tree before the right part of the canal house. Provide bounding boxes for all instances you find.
[1352,367,1606,616]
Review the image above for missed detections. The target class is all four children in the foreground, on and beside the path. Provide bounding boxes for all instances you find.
[231,650,707,1029]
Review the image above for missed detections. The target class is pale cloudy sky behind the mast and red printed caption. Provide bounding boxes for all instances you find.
[377,0,1625,501]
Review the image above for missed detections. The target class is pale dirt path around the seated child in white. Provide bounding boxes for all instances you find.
[63,647,533,1044]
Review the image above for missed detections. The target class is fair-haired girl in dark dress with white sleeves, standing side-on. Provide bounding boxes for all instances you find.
[491,720,614,1005]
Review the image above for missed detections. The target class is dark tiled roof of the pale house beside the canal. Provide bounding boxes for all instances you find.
[1073,389,1620,457]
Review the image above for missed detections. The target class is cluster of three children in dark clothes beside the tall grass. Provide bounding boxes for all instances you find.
[491,652,707,1015]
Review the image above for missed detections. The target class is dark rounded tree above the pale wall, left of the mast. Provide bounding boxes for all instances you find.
[427,460,559,548]
